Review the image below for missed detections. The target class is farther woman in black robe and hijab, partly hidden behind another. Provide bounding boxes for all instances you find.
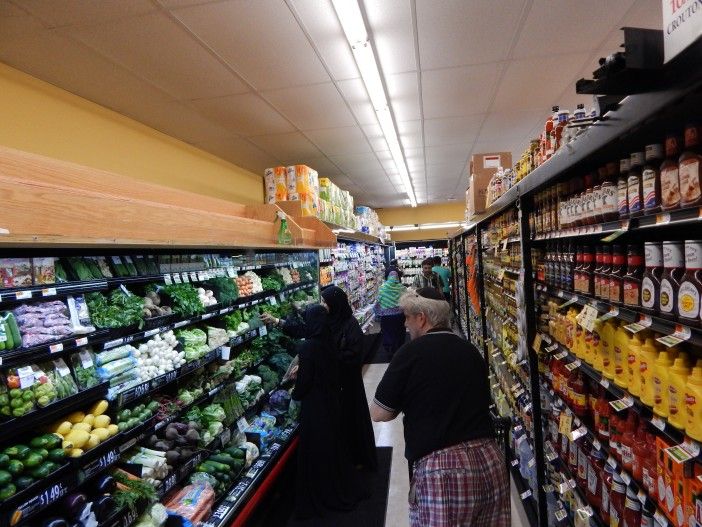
[322,286,378,470]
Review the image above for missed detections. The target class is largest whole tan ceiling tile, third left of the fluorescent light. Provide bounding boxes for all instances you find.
[62,13,248,99]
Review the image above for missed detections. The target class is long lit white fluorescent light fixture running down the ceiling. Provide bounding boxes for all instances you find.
[332,0,417,207]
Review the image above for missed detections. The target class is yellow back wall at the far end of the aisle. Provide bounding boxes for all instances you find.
[377,202,465,242]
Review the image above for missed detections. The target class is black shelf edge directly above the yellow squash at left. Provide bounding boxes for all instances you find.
[0,382,110,448]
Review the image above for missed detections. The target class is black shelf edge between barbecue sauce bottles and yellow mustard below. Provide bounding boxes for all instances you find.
[536,284,702,346]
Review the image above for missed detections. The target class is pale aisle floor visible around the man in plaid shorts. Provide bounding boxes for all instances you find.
[363,364,529,527]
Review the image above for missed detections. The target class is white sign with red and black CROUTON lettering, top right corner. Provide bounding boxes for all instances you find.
[661,0,702,62]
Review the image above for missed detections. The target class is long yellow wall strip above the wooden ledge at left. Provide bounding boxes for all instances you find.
[0,63,263,203]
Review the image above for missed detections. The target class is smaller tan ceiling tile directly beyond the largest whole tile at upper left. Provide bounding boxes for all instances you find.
[193,93,295,135]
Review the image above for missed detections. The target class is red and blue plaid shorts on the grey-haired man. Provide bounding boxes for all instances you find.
[409,439,511,527]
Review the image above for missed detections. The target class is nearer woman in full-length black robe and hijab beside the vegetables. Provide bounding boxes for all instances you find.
[292,304,363,518]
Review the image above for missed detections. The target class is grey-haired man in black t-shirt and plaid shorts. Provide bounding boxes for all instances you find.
[371,287,511,527]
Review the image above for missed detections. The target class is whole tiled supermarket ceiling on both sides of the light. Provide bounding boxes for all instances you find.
[0,0,661,207]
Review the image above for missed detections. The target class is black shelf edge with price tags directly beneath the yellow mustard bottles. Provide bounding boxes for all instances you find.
[542,334,702,454]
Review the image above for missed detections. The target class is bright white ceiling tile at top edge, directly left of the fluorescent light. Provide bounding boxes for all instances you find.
[292,0,359,80]
